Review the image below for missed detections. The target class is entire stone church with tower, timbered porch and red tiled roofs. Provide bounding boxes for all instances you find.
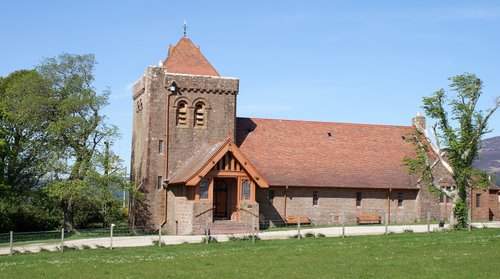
[129,36,500,235]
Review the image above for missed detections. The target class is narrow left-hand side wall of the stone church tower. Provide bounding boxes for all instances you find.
[131,67,165,227]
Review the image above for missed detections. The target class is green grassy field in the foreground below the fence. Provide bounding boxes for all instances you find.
[0,229,500,278]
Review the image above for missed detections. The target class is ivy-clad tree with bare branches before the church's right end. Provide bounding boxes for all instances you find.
[405,73,500,228]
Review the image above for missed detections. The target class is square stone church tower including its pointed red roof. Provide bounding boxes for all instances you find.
[129,36,239,231]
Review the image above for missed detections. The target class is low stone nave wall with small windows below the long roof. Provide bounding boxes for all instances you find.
[256,187,419,226]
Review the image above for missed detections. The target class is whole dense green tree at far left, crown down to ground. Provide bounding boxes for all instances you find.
[0,70,59,231]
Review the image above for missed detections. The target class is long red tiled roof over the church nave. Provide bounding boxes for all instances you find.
[236,118,418,189]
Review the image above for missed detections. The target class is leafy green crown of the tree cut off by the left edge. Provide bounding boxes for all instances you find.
[0,70,54,193]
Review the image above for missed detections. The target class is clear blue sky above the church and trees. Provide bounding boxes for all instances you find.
[0,0,500,173]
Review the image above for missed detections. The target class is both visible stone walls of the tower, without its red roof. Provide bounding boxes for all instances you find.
[130,67,239,233]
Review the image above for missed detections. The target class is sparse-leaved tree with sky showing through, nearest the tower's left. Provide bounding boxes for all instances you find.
[37,54,118,231]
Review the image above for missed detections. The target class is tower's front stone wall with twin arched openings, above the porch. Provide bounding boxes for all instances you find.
[164,74,239,179]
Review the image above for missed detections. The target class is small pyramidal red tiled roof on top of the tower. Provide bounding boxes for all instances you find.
[163,37,219,77]
